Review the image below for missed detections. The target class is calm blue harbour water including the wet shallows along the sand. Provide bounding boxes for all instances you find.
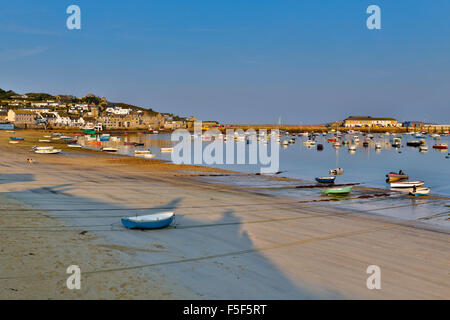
[78,134,450,228]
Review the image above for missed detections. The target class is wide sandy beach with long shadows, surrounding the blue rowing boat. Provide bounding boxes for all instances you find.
[0,132,450,299]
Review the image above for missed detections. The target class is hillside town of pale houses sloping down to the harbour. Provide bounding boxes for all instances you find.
[0,89,196,131]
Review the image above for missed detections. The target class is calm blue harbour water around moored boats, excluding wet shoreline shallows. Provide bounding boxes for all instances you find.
[81,134,450,196]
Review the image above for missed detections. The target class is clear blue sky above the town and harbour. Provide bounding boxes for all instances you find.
[0,0,450,124]
